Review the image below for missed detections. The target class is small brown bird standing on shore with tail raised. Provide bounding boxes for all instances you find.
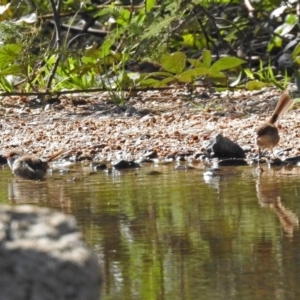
[256,90,294,155]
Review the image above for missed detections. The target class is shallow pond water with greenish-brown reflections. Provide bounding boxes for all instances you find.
[0,164,300,300]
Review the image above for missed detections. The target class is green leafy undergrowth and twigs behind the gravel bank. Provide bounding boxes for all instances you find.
[0,0,300,97]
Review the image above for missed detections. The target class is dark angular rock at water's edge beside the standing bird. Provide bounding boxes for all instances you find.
[206,134,245,158]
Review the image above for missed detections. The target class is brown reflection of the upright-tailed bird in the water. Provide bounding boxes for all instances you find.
[256,172,299,238]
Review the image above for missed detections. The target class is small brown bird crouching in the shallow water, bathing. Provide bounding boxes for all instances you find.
[5,150,66,180]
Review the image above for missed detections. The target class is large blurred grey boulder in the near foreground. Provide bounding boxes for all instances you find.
[0,205,102,300]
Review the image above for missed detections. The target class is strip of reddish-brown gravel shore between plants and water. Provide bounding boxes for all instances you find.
[0,89,300,166]
